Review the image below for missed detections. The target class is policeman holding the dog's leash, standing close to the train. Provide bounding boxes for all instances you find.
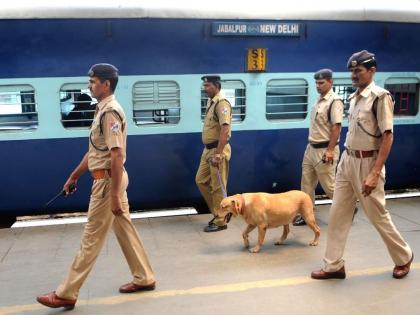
[195,75,232,232]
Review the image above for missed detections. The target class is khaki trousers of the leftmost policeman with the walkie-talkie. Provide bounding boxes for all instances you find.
[56,171,155,299]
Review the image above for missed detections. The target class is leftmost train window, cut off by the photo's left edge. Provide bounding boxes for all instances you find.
[0,85,38,131]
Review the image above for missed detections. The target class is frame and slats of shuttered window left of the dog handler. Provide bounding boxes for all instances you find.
[132,80,182,128]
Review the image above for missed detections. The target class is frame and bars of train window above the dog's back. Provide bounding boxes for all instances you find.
[265,78,309,122]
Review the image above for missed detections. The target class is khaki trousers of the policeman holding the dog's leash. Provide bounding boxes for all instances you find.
[195,144,231,226]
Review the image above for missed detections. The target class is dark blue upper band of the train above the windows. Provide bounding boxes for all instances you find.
[0,18,420,78]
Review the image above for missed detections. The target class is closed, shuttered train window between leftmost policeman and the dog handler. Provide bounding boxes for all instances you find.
[133,81,181,126]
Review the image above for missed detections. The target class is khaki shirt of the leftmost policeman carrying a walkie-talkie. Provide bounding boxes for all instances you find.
[88,95,127,171]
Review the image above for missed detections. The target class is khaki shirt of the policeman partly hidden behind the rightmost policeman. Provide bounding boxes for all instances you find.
[308,89,344,143]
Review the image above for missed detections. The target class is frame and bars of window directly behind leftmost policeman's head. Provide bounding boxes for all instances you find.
[59,82,97,130]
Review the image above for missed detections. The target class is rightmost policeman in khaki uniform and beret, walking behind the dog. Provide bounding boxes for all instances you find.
[311,50,414,279]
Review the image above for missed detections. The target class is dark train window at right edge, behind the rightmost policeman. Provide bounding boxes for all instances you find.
[385,78,420,116]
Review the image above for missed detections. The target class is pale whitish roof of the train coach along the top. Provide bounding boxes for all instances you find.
[0,0,420,23]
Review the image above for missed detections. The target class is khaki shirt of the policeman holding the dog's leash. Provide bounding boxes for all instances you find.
[202,93,232,144]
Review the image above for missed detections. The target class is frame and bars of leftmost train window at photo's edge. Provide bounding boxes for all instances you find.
[0,83,39,132]
